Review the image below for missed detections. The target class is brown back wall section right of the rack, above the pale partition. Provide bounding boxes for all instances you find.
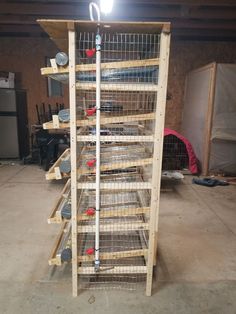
[166,41,236,131]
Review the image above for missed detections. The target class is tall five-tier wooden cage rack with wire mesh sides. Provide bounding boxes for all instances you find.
[39,20,170,296]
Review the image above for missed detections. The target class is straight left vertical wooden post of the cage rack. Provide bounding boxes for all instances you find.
[68,22,78,297]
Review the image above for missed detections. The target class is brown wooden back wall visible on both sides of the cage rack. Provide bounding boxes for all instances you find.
[0,38,236,131]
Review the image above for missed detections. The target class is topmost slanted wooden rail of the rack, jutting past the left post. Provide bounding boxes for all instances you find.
[41,58,159,75]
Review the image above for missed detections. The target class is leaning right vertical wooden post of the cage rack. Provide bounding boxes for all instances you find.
[146,30,170,296]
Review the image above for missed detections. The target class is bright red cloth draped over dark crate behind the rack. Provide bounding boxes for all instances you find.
[164,128,198,174]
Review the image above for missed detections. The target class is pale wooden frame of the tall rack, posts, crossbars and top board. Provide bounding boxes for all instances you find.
[40,20,170,296]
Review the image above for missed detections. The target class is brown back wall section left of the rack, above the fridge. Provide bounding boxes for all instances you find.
[0,38,68,125]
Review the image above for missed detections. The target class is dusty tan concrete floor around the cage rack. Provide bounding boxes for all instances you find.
[0,165,236,314]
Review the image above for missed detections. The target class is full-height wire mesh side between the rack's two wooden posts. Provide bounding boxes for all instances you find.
[71,32,160,289]
